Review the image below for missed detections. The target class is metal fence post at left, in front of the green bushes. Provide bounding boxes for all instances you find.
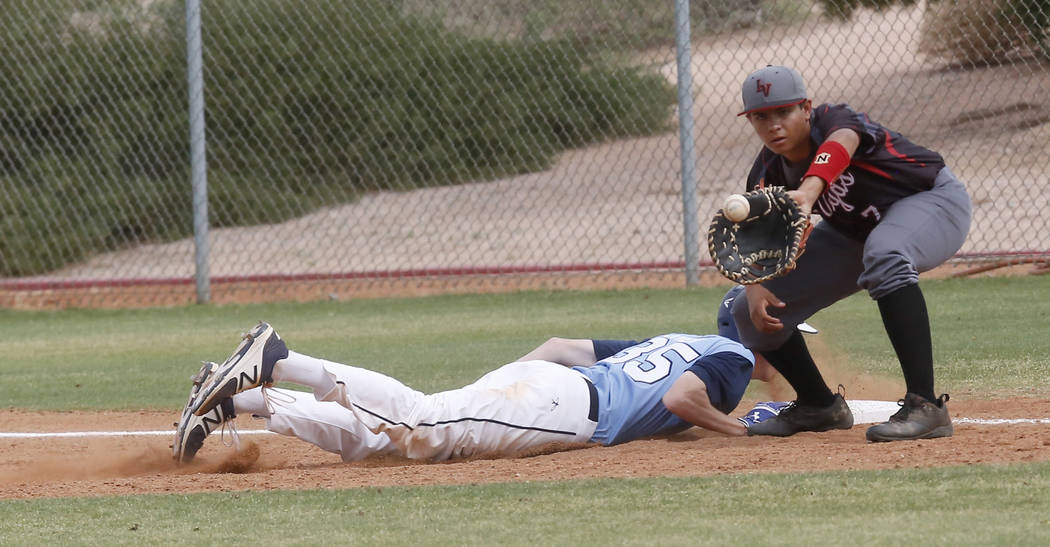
[186,0,211,303]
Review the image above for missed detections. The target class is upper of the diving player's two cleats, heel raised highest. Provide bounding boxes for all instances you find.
[193,322,288,416]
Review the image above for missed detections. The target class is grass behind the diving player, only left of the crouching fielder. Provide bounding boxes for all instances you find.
[0,290,734,409]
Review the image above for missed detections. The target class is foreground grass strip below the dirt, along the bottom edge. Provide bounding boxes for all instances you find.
[0,463,1050,545]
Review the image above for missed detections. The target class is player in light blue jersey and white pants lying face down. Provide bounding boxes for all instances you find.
[172,288,778,462]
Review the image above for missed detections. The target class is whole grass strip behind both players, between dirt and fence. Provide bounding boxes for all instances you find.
[0,277,1050,411]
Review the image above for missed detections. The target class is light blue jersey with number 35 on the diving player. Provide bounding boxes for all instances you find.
[573,334,755,445]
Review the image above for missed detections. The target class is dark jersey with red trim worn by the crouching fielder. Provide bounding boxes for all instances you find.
[748,104,944,240]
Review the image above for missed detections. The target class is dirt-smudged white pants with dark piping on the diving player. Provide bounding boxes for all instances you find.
[306,361,597,461]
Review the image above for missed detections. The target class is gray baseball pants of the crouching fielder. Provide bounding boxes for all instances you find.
[733,167,971,352]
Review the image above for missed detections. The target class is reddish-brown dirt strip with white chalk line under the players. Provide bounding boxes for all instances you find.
[0,398,1050,499]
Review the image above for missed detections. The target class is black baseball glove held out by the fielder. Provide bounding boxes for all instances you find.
[708,186,812,285]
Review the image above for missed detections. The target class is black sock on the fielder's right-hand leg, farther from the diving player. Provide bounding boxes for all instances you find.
[878,285,937,401]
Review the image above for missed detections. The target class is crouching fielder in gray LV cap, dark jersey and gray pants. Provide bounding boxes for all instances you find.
[733,65,971,441]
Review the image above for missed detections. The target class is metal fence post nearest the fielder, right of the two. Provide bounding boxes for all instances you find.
[674,0,700,287]
